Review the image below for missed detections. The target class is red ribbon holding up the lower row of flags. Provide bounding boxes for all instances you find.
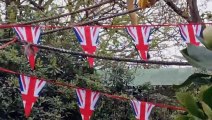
[0,67,185,111]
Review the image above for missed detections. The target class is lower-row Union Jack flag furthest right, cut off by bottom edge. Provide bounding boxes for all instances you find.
[131,100,154,120]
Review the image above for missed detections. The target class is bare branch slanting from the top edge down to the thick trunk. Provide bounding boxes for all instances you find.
[164,0,193,22]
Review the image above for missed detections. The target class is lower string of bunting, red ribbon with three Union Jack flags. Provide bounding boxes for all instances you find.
[0,67,185,120]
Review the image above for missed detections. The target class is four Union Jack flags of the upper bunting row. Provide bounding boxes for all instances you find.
[4,24,203,67]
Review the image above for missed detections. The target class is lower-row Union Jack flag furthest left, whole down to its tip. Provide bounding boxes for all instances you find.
[19,75,46,117]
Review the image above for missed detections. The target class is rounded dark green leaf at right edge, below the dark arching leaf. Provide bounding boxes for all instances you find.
[202,86,212,108]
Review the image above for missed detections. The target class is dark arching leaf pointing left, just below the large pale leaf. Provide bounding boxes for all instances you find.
[173,73,212,88]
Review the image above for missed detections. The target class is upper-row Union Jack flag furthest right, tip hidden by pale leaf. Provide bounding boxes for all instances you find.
[179,24,202,46]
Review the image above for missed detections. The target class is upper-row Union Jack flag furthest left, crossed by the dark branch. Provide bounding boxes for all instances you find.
[14,26,41,70]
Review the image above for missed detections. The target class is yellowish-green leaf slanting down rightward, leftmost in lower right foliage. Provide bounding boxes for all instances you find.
[176,93,206,119]
